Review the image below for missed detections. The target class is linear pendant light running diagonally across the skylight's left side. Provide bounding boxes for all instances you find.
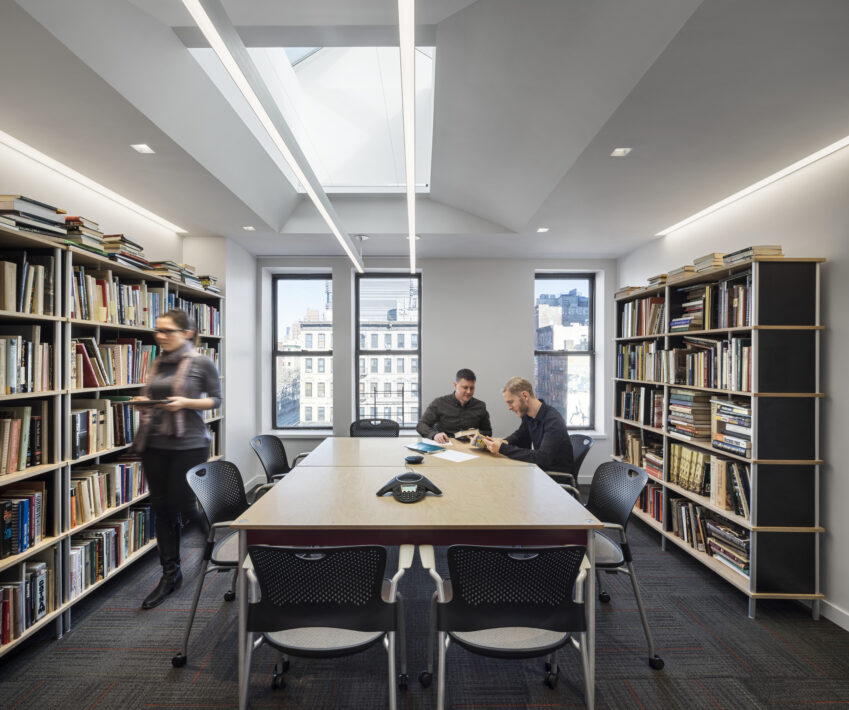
[183,0,365,273]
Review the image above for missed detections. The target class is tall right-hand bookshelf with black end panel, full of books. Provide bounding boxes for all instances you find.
[614,258,824,618]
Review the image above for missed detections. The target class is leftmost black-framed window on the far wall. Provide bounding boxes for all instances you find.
[271,274,333,429]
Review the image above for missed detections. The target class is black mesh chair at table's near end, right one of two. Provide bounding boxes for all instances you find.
[419,545,592,710]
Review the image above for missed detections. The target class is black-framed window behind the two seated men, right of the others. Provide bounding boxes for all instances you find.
[534,274,595,429]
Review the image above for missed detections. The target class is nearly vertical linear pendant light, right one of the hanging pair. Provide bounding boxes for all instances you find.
[398,0,416,274]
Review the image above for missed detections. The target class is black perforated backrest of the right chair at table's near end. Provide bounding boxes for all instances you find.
[437,545,586,631]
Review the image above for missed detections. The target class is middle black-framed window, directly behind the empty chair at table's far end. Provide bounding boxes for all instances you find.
[354,274,421,428]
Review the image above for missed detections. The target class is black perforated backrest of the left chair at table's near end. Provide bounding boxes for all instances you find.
[242,545,395,631]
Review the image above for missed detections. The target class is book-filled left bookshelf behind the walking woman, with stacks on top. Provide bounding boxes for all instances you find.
[0,218,224,656]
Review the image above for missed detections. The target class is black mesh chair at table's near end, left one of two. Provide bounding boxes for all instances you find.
[242,545,415,710]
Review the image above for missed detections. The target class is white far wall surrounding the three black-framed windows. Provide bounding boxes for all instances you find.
[256,258,614,480]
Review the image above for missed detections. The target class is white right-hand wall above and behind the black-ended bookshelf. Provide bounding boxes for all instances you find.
[618,143,849,629]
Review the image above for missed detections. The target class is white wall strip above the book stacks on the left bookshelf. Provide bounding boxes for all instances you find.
[0,144,182,261]
